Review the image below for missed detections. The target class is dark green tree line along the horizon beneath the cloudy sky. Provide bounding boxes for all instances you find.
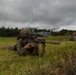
[0,27,76,37]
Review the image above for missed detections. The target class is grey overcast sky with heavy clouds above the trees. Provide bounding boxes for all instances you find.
[0,0,76,30]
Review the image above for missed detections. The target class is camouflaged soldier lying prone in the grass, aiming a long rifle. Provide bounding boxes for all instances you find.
[9,28,45,55]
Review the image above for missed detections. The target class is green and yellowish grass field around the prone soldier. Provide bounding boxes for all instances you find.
[0,36,76,75]
